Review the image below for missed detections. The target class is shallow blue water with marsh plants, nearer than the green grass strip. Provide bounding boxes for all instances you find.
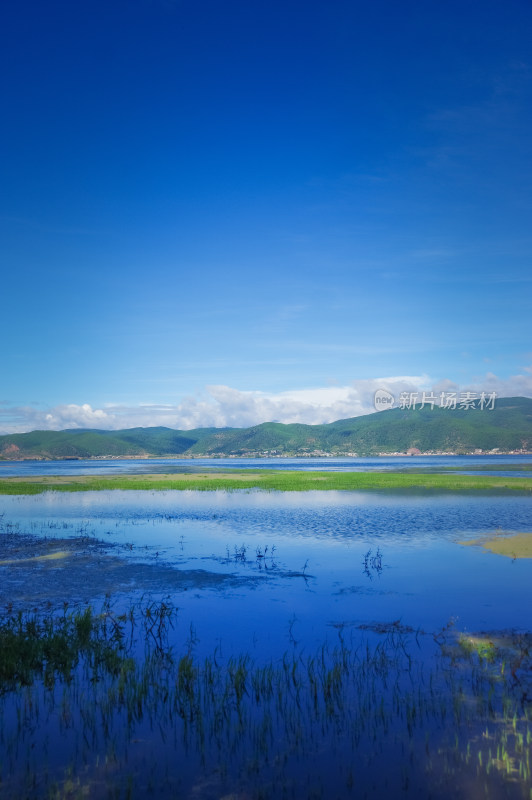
[0,490,532,798]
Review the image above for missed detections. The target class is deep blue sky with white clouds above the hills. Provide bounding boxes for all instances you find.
[0,0,532,432]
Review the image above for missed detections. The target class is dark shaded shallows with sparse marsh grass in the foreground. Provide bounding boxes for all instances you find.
[0,602,532,798]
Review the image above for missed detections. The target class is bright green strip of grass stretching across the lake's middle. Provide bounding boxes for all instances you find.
[0,470,532,494]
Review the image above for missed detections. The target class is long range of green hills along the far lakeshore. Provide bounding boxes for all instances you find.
[0,397,532,460]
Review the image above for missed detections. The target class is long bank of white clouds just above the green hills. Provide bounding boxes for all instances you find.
[0,367,532,433]
